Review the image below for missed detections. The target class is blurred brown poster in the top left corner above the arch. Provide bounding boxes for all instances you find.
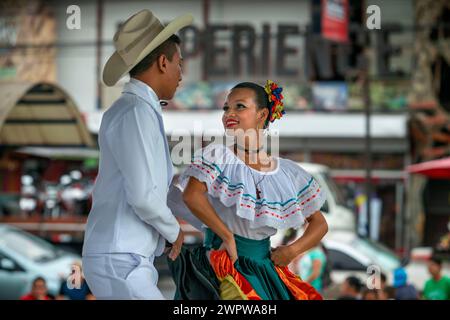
[0,0,57,82]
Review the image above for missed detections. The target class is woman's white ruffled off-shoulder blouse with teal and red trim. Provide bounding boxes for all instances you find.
[169,144,326,240]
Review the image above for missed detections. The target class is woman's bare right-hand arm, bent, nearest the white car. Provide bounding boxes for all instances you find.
[271,211,328,266]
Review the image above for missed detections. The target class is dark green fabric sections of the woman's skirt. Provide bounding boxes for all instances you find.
[168,229,294,300]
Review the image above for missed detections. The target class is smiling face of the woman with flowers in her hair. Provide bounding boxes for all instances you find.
[222,88,268,132]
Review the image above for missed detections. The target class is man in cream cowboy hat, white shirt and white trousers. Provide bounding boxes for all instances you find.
[83,10,193,299]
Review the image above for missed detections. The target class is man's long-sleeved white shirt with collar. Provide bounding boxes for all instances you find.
[83,78,180,256]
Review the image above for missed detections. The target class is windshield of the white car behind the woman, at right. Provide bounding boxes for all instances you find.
[352,238,401,270]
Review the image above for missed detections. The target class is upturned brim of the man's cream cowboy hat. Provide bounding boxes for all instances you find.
[103,14,194,87]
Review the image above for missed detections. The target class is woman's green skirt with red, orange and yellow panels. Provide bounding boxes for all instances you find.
[168,229,322,300]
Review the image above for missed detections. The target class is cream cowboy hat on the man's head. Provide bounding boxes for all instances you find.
[103,10,194,86]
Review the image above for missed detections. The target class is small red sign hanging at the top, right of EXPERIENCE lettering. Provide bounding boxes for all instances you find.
[321,0,349,42]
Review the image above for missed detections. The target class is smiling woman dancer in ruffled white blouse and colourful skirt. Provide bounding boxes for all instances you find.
[172,81,328,300]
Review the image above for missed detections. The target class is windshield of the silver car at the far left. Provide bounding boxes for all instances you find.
[0,230,58,262]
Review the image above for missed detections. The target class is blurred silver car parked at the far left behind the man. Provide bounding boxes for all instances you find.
[0,224,81,299]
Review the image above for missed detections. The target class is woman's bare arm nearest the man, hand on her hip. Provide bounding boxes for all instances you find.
[183,177,238,263]
